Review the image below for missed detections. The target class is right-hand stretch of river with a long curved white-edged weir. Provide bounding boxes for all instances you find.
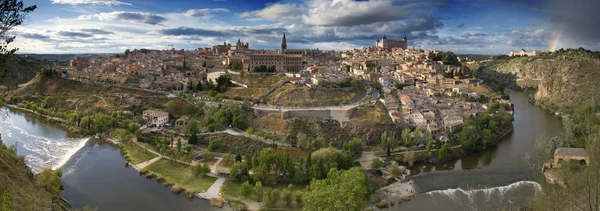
[390,91,562,211]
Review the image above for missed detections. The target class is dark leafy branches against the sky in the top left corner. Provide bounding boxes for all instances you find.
[0,0,37,84]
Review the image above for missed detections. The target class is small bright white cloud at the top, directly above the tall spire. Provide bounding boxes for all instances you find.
[240,4,301,20]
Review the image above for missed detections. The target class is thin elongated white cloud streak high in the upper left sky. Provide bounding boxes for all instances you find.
[77,11,167,25]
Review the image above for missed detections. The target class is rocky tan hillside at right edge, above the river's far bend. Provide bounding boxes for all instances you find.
[470,50,600,111]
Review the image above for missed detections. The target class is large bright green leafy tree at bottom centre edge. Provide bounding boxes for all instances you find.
[304,167,369,211]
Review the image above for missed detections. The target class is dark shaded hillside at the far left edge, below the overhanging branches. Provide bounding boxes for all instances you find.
[3,56,53,86]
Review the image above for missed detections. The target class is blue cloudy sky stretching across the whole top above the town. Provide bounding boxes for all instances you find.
[11,0,600,54]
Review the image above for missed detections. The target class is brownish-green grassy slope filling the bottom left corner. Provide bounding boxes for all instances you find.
[0,149,60,210]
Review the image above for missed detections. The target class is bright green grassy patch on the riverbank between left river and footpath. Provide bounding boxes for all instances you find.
[145,159,217,193]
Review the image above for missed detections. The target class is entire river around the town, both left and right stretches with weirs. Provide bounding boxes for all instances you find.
[0,92,561,211]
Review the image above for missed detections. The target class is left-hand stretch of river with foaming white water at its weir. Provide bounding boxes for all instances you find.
[0,109,230,211]
